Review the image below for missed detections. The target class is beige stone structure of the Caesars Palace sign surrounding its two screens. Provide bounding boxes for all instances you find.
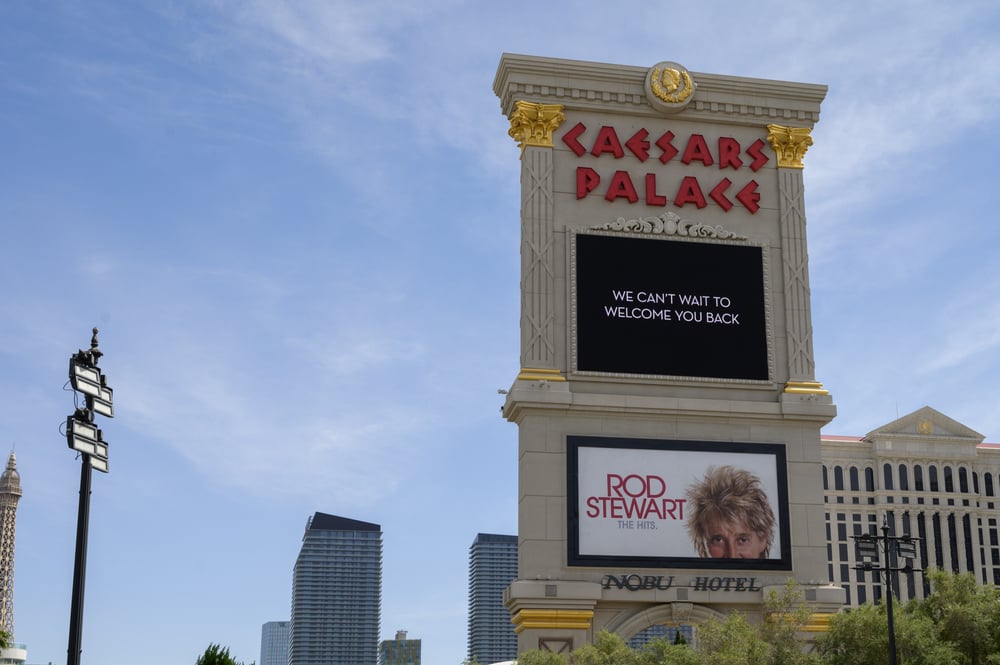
[494,54,844,651]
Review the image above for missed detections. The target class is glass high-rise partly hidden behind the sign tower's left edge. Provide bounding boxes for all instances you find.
[468,533,517,665]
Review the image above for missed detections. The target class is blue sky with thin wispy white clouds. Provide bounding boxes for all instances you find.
[0,0,1000,665]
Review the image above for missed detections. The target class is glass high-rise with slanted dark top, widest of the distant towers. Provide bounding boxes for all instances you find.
[288,513,382,665]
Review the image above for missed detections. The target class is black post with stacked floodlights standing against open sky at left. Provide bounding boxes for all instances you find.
[66,328,114,665]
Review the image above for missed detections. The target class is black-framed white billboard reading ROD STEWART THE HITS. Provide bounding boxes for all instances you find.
[566,435,791,570]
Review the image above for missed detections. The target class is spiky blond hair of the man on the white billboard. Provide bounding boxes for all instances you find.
[687,465,774,559]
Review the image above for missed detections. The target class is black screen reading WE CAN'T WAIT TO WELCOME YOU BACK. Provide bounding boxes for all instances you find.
[574,233,771,381]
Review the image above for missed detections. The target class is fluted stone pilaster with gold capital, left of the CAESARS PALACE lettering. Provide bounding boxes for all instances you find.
[509,101,565,381]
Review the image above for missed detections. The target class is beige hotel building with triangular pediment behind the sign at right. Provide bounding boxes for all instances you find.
[822,407,1000,606]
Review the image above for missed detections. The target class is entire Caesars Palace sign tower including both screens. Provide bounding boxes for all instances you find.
[494,54,843,652]
